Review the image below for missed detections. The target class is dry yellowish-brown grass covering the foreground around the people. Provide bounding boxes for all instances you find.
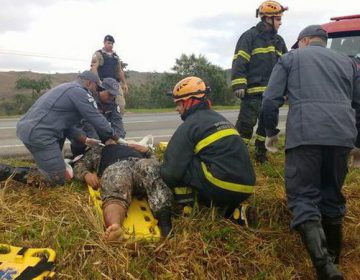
[0,148,360,280]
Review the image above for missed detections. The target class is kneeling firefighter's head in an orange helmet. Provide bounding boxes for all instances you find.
[172,76,210,115]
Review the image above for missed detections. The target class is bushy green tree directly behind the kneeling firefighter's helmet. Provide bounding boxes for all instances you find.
[171,54,234,105]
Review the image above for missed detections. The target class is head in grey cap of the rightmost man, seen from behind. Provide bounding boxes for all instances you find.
[292,25,328,49]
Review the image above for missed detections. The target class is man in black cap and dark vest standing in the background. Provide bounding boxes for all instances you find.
[91,35,128,115]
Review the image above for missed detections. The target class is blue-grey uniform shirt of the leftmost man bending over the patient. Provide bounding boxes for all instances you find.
[16,81,114,147]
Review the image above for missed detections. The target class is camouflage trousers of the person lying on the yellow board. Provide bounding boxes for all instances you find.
[101,158,173,213]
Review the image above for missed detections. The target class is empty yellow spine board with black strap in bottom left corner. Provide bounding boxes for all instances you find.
[0,244,56,280]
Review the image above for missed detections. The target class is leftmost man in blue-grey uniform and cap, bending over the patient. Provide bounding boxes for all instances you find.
[16,71,118,185]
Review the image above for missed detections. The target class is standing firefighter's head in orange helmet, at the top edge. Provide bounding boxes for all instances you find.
[256,1,288,32]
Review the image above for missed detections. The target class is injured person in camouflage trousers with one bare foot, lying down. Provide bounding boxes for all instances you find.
[74,142,173,241]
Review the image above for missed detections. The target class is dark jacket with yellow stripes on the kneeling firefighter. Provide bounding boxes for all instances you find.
[160,103,255,193]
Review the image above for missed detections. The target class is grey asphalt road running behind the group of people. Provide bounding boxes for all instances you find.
[0,109,287,158]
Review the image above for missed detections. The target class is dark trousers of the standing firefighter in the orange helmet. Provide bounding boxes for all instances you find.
[235,94,266,155]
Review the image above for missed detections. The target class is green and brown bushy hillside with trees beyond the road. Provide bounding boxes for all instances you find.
[0,54,239,116]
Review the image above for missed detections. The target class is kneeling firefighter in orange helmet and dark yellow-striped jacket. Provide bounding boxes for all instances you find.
[160,77,256,226]
